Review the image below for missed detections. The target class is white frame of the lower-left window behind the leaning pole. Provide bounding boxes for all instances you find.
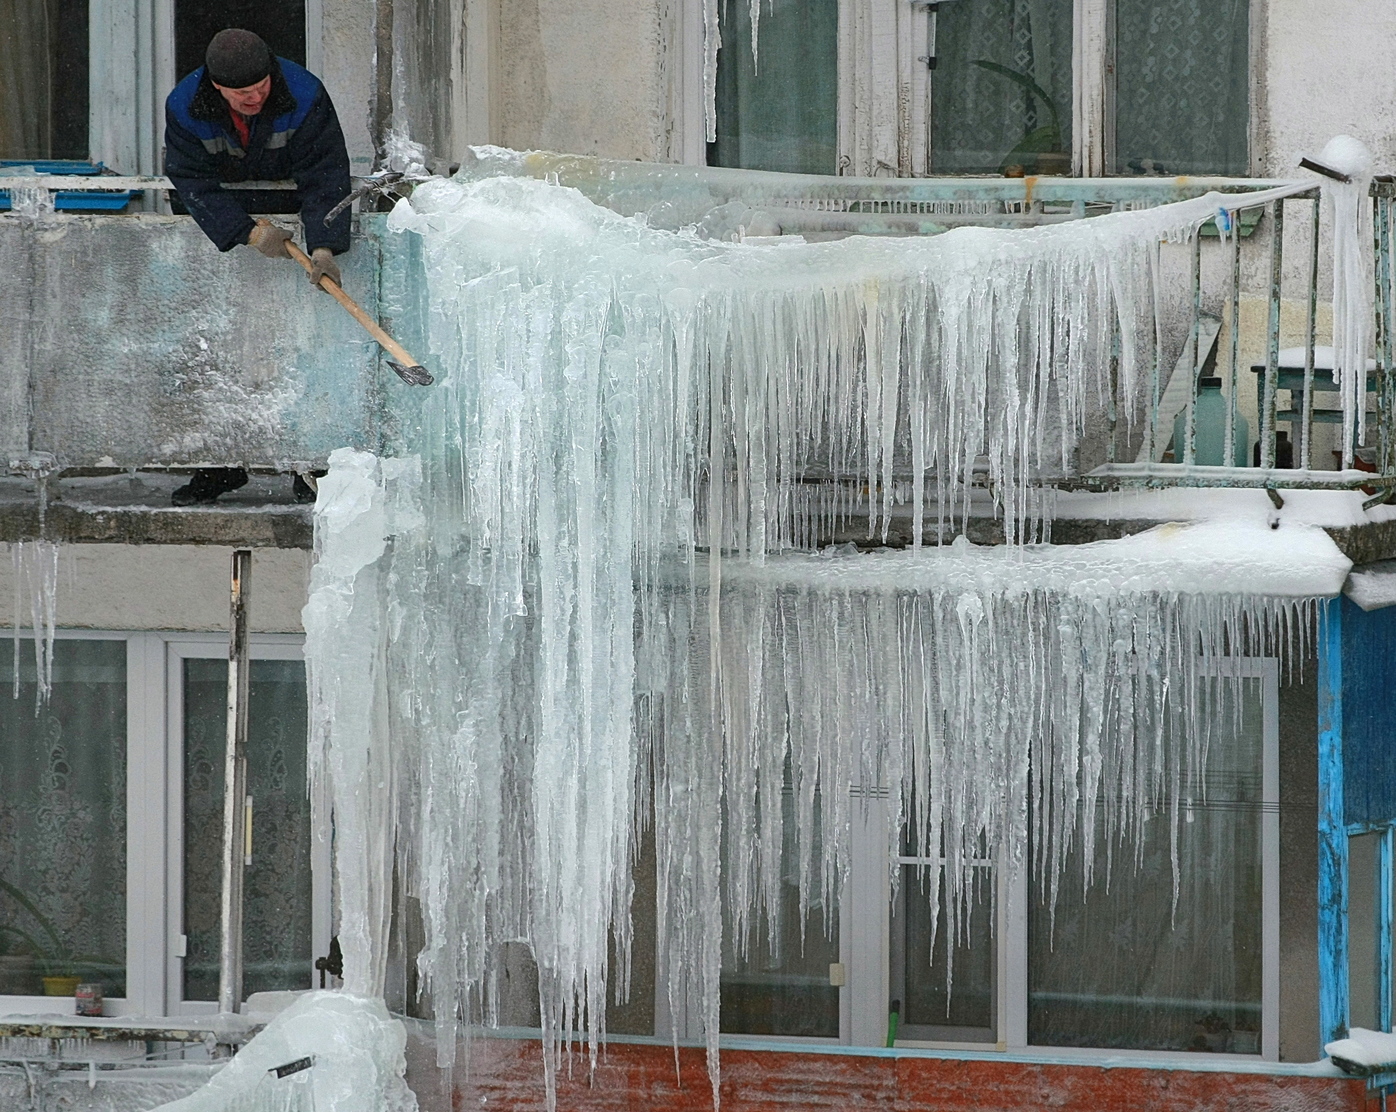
[0,629,323,1016]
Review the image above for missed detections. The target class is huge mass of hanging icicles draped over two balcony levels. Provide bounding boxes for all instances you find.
[306,177,1349,1099]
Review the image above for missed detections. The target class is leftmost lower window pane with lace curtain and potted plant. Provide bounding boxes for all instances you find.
[0,638,126,1010]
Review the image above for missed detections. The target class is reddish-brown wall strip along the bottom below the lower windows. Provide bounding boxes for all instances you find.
[441,1039,1365,1112]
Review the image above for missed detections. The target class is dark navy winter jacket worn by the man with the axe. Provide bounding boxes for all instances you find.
[165,59,349,254]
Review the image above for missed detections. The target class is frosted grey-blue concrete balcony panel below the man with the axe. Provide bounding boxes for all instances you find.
[0,215,401,467]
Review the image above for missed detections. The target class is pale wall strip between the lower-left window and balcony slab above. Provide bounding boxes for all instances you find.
[0,544,310,633]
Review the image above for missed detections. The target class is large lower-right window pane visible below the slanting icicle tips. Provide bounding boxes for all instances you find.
[1027,679,1262,1053]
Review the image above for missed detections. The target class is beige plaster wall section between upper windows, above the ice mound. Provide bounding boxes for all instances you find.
[491,0,669,162]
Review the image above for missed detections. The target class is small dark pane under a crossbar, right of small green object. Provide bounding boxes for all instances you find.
[892,864,998,1042]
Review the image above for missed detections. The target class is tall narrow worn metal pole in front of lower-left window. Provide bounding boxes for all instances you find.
[218,548,253,1012]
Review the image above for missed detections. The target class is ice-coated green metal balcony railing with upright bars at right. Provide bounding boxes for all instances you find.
[462,146,1396,506]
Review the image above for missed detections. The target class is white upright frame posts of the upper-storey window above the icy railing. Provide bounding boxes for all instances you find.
[669,0,1266,177]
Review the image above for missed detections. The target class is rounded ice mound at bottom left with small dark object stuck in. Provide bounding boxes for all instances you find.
[155,992,417,1112]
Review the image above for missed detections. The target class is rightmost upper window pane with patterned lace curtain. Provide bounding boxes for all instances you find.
[1115,0,1251,174]
